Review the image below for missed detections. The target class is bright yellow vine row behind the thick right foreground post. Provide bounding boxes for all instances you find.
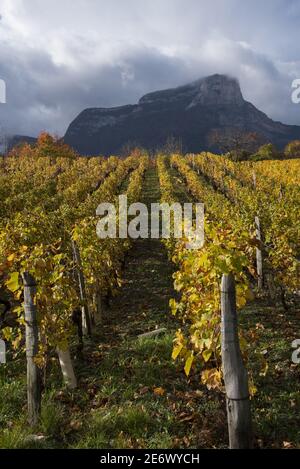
[158,156,254,388]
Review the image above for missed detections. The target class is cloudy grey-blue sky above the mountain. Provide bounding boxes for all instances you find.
[0,0,300,136]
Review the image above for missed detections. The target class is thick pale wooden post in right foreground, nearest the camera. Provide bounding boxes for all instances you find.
[221,274,252,449]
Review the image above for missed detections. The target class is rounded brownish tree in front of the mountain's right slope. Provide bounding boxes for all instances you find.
[209,127,262,161]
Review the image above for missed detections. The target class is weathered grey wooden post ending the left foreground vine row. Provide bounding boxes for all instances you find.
[22,272,41,425]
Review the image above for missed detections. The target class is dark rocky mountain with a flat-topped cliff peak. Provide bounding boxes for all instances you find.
[64,75,300,155]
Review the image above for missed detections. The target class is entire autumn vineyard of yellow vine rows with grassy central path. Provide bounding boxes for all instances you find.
[0,134,300,448]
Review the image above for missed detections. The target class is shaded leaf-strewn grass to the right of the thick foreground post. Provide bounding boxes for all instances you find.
[241,303,300,448]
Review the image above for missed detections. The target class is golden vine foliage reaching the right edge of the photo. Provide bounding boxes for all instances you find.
[188,153,300,291]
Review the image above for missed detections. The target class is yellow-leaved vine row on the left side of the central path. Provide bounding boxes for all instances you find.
[0,143,145,361]
